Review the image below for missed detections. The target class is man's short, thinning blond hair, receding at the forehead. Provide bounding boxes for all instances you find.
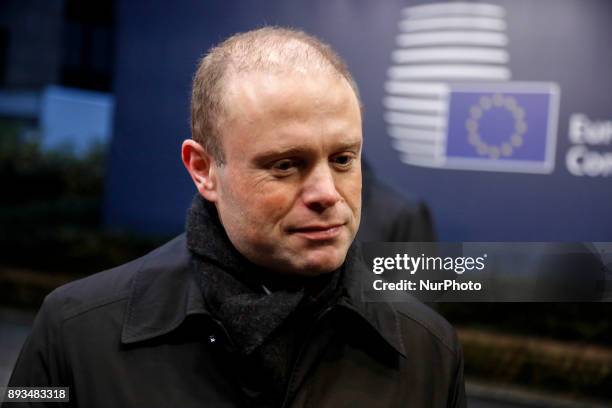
[191,27,361,164]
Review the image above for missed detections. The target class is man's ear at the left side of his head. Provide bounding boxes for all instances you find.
[181,139,218,202]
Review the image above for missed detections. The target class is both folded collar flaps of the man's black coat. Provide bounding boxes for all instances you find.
[121,234,406,356]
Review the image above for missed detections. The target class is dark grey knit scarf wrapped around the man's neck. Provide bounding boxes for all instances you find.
[186,194,342,404]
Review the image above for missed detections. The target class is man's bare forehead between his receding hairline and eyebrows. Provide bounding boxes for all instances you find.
[223,72,361,153]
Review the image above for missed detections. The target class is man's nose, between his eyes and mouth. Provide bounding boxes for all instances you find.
[302,163,341,212]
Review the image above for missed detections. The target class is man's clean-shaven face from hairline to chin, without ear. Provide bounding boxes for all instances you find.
[211,73,362,275]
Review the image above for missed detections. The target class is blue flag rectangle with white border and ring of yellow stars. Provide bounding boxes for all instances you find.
[442,82,559,173]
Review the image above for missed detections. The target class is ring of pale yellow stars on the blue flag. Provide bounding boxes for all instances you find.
[465,93,527,159]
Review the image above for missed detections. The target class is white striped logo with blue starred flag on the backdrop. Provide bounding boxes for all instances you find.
[383,3,559,173]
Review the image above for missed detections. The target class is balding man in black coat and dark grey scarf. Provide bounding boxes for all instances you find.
[4,28,465,408]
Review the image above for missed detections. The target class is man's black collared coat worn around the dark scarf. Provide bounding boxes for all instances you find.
[7,235,466,408]
